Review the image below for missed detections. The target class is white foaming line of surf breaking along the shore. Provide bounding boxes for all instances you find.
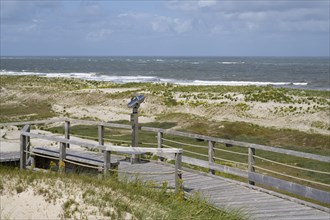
[0,70,308,86]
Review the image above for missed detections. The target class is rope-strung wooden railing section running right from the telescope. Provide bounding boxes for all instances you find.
[148,127,330,203]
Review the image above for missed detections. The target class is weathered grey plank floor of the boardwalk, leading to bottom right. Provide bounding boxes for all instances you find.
[119,162,330,220]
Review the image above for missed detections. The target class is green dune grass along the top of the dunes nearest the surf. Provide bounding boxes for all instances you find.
[0,76,330,122]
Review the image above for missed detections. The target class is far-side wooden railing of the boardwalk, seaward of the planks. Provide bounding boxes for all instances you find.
[0,119,330,204]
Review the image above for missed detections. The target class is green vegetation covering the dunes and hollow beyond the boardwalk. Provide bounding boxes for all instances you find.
[0,76,330,206]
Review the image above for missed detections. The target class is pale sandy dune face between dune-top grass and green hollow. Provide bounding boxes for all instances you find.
[1,80,330,135]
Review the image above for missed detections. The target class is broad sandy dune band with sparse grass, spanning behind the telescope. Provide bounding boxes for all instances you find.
[0,78,330,135]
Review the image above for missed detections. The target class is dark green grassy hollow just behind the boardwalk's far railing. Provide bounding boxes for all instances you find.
[44,118,330,190]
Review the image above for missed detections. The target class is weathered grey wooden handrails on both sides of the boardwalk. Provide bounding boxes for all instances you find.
[8,119,330,203]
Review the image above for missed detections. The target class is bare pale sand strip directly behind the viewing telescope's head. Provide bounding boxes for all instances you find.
[49,88,330,135]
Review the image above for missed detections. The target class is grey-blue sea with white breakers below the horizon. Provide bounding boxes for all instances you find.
[0,56,330,90]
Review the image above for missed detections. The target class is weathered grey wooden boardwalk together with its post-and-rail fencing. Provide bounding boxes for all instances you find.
[0,119,330,219]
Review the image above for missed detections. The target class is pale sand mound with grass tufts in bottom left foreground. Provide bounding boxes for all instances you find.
[0,177,136,220]
